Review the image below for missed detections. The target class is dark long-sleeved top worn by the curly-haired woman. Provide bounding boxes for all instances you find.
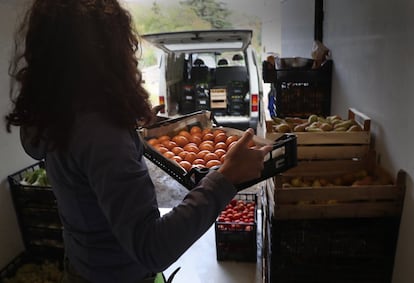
[22,114,236,283]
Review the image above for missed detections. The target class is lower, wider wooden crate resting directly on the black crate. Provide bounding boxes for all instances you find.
[268,152,406,219]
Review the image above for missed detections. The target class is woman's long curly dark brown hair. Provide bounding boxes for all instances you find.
[5,0,152,151]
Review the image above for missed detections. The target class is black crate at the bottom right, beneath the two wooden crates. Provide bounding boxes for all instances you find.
[270,218,399,283]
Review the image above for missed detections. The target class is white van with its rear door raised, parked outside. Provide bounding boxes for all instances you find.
[142,30,263,130]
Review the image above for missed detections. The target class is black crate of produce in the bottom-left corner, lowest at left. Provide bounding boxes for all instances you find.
[0,250,63,283]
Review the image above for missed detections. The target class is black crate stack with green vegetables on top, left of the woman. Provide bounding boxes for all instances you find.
[8,162,64,259]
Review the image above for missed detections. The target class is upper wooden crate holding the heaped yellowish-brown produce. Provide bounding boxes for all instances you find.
[266,108,371,160]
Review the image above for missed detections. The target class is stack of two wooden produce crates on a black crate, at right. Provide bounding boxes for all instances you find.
[267,109,405,283]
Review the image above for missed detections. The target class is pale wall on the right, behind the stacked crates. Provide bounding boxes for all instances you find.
[282,0,414,283]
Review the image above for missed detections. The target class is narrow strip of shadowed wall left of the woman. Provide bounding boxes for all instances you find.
[0,0,34,270]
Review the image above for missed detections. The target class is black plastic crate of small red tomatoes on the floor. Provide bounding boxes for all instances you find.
[214,193,258,262]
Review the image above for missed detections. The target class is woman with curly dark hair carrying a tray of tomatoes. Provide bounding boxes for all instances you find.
[6,0,270,283]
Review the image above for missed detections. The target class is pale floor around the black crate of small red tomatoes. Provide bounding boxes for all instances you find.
[146,160,263,283]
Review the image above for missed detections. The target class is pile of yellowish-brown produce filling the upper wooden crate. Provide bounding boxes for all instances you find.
[272,114,363,133]
